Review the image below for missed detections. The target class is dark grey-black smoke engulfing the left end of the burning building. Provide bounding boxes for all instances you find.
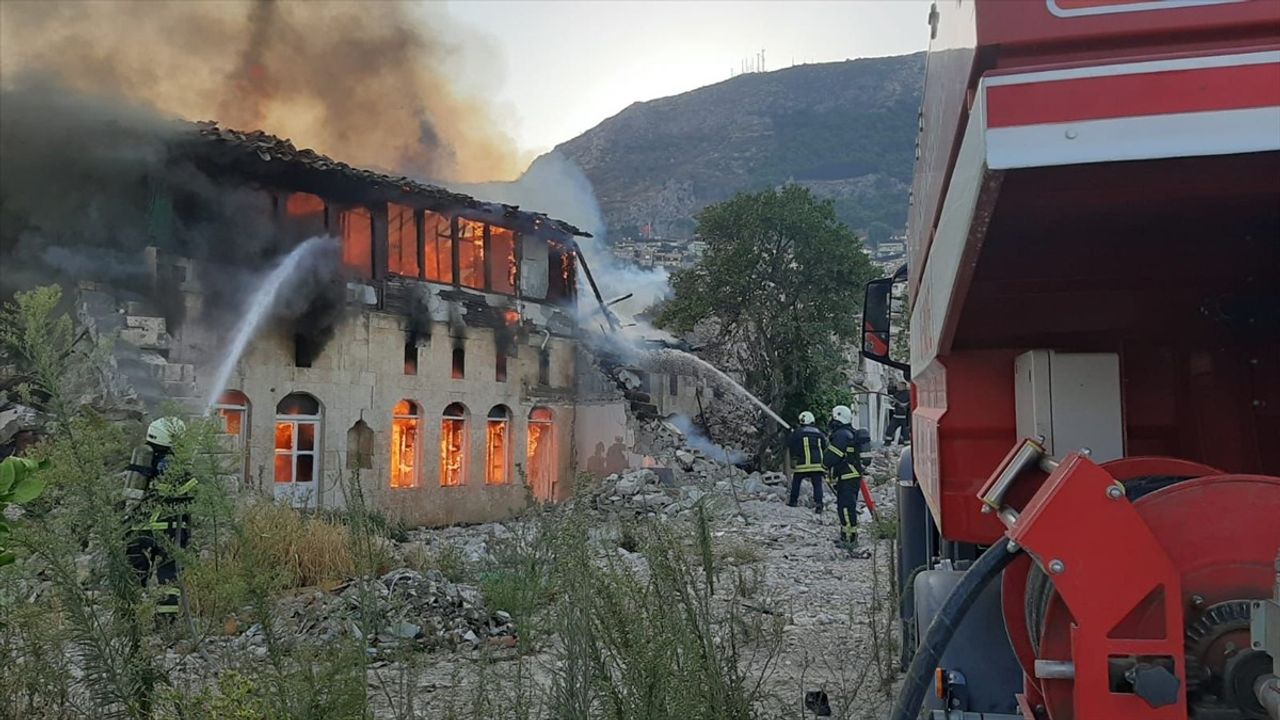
[0,79,344,345]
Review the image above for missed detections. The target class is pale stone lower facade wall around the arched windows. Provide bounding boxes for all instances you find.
[207,310,575,525]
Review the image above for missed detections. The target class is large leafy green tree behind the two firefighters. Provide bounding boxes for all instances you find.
[657,184,876,427]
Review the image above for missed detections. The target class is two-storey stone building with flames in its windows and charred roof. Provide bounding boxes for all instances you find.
[48,124,586,524]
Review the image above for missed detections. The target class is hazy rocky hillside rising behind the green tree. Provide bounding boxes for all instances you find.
[556,54,924,240]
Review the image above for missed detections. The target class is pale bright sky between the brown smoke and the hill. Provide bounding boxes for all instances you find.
[445,0,929,152]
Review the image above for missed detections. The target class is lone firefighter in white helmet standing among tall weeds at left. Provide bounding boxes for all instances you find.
[124,418,196,616]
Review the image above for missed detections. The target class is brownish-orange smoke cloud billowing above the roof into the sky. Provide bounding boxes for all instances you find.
[0,0,520,182]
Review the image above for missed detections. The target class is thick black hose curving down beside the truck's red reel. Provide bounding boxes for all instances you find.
[890,541,1021,720]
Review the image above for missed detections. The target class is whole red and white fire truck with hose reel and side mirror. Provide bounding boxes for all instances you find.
[864,0,1280,720]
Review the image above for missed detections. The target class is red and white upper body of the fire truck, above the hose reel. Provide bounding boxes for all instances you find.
[908,0,1280,543]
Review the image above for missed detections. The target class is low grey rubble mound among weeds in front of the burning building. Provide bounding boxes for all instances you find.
[233,568,516,655]
